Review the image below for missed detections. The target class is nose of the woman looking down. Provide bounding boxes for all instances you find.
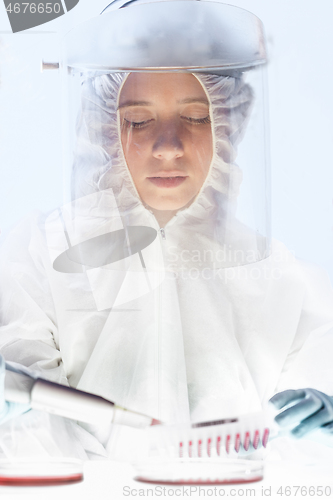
[153,123,184,161]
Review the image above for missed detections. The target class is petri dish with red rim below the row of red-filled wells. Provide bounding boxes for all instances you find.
[134,457,264,484]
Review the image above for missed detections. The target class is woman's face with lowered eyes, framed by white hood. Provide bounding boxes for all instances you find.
[118,73,213,210]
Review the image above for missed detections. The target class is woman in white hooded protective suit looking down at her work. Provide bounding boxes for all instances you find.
[0,0,333,456]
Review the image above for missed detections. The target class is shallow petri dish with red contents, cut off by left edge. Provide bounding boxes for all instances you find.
[0,458,83,486]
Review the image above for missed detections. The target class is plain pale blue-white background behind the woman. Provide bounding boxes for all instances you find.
[0,0,333,281]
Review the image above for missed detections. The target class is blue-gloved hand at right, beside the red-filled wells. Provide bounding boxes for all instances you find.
[270,389,333,438]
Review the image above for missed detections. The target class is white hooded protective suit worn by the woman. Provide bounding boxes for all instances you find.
[0,71,333,456]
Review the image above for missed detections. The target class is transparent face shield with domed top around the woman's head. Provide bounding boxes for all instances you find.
[59,2,270,274]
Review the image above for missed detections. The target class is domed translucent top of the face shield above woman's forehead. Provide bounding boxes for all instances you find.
[65,0,266,71]
